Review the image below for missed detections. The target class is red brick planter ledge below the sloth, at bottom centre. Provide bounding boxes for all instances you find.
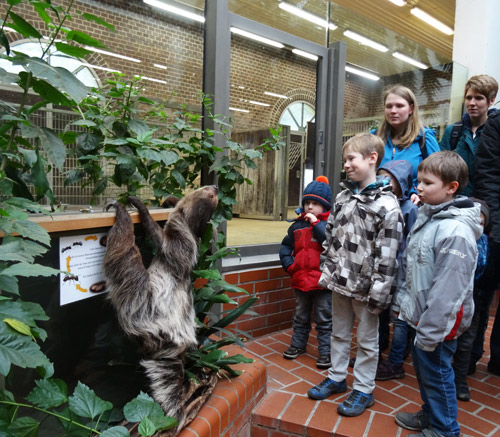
[179,346,267,437]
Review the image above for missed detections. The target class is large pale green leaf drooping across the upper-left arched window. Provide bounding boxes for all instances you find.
[13,57,90,102]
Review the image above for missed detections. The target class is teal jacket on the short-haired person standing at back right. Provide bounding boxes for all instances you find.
[439,108,497,196]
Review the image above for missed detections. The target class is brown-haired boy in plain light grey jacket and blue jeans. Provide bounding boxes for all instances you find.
[396,151,482,437]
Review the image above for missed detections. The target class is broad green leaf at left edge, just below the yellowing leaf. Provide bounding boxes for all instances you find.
[0,322,49,375]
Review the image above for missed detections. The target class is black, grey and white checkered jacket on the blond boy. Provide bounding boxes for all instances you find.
[319,177,403,314]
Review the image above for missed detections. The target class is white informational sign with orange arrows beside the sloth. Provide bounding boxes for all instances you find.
[59,233,106,305]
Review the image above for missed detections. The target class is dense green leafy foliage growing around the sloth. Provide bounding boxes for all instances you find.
[0,0,281,437]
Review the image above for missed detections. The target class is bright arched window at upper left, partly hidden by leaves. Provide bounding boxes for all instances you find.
[0,41,99,88]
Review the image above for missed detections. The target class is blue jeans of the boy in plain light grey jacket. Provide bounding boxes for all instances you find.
[412,340,460,437]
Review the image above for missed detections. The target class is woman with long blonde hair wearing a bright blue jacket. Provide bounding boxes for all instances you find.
[371,85,440,204]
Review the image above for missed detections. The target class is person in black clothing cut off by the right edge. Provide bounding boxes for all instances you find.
[470,113,500,375]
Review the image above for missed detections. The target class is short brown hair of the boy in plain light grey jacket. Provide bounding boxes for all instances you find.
[417,150,469,196]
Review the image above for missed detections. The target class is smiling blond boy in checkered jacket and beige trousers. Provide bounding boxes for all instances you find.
[307,134,403,416]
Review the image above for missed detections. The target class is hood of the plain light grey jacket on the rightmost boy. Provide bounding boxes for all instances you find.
[416,196,483,240]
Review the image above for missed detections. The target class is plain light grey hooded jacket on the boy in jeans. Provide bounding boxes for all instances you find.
[400,196,482,351]
